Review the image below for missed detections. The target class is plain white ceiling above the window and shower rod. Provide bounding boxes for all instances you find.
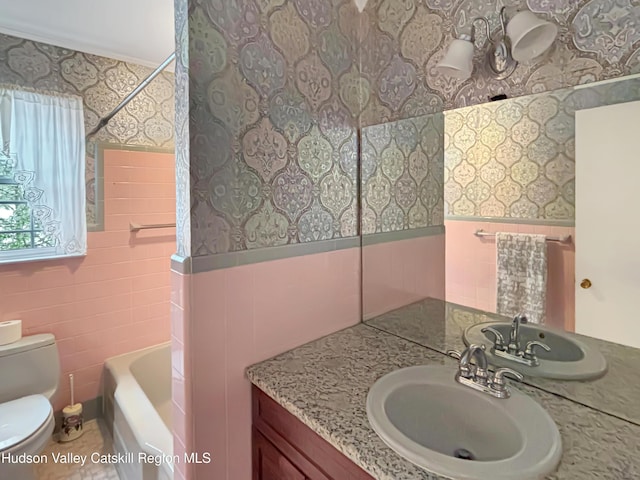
[0,0,175,67]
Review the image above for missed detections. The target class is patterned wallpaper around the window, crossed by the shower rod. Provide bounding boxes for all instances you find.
[0,34,174,224]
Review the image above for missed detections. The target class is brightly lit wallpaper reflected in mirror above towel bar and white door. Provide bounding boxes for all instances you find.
[444,78,640,223]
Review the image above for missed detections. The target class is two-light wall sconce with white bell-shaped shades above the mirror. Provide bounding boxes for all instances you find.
[436,7,558,80]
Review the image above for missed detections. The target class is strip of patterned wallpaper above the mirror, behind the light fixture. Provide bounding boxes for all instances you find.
[358,0,640,125]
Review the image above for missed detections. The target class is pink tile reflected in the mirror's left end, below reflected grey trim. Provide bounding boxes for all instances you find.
[362,235,445,320]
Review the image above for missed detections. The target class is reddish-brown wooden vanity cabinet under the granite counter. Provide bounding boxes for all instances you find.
[252,386,374,480]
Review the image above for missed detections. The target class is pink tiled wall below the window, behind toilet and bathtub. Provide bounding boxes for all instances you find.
[0,150,175,408]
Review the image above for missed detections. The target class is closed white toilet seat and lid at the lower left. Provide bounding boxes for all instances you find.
[0,395,55,453]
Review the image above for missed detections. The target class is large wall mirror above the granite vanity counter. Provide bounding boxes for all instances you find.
[361,75,640,422]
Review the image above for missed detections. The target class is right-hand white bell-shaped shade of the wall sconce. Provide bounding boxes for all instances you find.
[507,10,558,62]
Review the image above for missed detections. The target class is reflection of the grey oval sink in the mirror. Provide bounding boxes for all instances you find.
[463,322,607,380]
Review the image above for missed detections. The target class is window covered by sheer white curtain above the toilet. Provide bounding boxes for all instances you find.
[0,88,86,264]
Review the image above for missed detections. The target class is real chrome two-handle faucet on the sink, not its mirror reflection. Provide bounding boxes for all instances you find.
[447,344,523,398]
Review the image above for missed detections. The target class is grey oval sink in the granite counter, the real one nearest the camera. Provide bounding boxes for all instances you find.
[367,366,562,480]
